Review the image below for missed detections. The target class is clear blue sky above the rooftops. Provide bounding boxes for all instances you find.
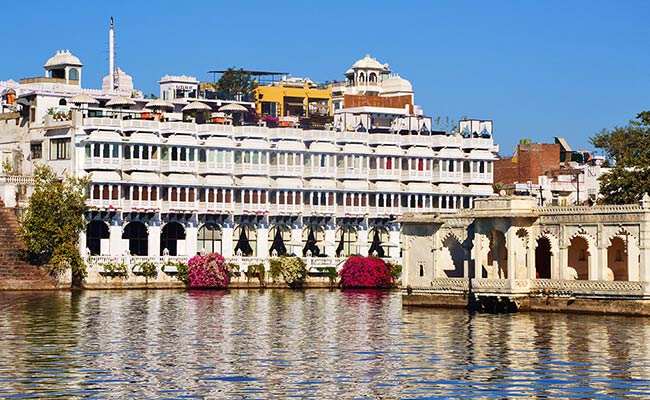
[0,0,650,155]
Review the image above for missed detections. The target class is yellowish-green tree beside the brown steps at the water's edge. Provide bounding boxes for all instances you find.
[20,165,90,283]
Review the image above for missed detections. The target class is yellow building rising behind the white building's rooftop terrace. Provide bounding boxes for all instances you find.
[255,78,332,118]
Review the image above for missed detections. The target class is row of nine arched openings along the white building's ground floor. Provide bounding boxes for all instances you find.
[86,220,389,256]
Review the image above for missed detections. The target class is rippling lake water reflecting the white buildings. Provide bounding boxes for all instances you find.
[0,290,650,399]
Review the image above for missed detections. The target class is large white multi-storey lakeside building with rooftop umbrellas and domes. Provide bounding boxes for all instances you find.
[0,47,497,276]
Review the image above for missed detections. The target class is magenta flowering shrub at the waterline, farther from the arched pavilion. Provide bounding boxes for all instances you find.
[187,253,232,288]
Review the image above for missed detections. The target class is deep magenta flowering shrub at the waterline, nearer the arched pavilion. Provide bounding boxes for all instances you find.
[339,256,393,288]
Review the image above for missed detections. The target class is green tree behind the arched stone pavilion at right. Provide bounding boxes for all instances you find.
[590,111,650,204]
